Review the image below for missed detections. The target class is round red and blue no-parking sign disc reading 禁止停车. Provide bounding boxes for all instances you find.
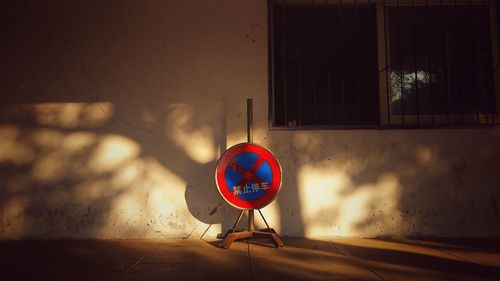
[215,143,281,210]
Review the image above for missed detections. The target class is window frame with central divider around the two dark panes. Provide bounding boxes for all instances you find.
[267,0,500,130]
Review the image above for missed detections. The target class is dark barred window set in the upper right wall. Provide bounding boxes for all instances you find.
[269,0,500,128]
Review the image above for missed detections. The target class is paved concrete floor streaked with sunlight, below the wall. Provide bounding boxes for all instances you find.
[0,238,500,281]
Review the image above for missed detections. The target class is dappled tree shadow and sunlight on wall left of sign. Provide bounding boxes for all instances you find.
[0,99,244,238]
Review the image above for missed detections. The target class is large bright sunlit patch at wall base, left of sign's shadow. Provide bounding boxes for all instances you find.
[100,158,197,237]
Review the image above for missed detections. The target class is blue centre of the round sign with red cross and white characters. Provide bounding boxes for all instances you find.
[224,152,273,200]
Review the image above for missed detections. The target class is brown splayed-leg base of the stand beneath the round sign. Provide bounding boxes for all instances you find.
[222,209,285,249]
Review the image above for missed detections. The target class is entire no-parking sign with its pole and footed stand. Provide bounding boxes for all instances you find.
[215,99,285,249]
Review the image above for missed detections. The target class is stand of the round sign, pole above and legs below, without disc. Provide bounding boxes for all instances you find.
[222,99,285,249]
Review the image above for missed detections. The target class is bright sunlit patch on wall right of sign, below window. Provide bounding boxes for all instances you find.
[299,162,401,237]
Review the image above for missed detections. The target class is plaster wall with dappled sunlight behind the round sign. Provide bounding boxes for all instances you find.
[0,0,500,239]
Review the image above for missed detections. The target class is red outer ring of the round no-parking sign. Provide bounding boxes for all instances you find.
[215,142,282,210]
